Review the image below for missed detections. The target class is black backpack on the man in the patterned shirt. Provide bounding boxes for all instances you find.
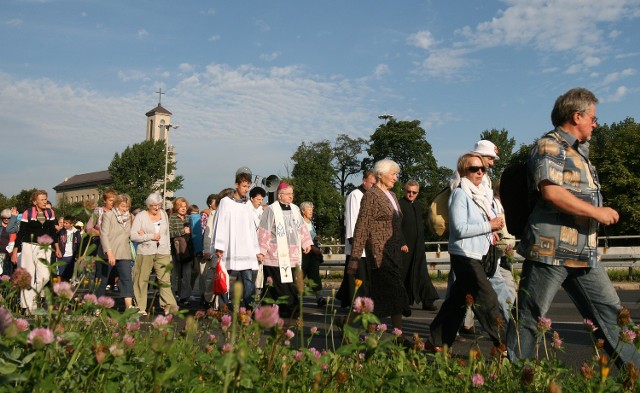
[500,131,570,239]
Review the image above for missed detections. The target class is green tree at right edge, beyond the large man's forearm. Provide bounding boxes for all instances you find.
[590,117,640,235]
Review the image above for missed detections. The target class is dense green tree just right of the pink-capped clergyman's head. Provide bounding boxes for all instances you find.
[291,140,343,238]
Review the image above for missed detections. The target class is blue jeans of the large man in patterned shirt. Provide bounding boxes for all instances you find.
[507,260,640,366]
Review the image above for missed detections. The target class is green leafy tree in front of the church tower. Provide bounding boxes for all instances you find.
[109,140,183,207]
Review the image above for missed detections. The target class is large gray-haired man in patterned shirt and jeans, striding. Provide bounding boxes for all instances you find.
[507,88,640,366]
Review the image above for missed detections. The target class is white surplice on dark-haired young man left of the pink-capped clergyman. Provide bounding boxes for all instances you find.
[211,197,260,271]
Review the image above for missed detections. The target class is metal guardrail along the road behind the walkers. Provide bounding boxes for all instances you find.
[320,235,640,277]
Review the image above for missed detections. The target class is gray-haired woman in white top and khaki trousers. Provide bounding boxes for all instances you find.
[131,193,177,315]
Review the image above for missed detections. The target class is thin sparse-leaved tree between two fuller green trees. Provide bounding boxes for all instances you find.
[332,134,367,196]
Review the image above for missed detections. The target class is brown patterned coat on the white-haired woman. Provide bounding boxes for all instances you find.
[350,186,405,269]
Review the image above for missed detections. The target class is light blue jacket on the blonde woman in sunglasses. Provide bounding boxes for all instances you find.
[449,187,492,260]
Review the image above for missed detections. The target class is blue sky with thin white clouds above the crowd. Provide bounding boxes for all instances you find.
[0,0,640,207]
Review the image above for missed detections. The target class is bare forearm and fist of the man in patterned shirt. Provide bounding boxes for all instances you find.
[539,180,620,225]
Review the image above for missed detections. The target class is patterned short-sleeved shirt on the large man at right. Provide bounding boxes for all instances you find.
[518,128,602,267]
